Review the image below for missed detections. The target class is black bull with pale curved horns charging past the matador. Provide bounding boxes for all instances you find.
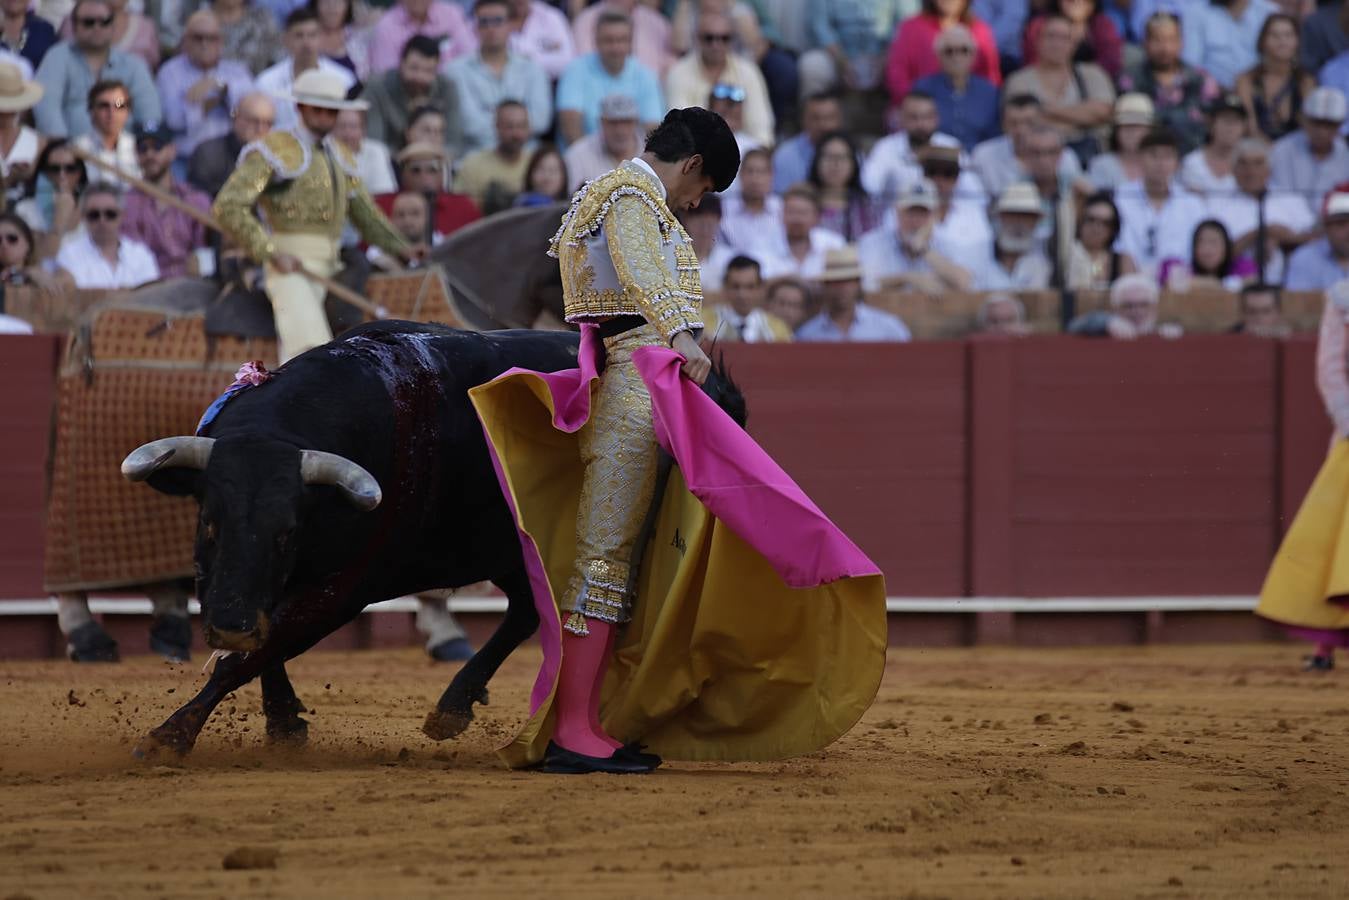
[123,321,745,757]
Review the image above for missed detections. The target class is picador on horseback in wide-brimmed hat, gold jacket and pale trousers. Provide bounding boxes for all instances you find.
[214,69,426,362]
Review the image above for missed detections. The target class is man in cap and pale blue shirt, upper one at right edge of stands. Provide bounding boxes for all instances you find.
[1269,88,1349,222]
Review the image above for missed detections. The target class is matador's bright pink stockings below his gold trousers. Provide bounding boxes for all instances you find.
[553,619,618,758]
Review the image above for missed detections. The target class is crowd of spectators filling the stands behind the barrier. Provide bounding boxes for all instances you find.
[0,0,1349,341]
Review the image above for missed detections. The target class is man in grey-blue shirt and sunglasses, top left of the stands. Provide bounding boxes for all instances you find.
[32,0,163,138]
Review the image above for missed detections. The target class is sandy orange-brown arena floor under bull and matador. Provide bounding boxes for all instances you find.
[0,645,1349,900]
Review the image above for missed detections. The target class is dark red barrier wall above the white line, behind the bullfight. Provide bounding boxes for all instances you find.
[0,337,1329,604]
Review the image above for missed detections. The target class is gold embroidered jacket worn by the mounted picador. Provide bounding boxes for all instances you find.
[213,131,407,262]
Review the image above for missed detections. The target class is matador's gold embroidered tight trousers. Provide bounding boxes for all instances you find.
[564,325,665,634]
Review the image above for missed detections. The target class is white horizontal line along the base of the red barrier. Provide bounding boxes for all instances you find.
[0,595,1256,615]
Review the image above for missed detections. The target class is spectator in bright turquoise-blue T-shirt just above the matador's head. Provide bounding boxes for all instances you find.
[557,9,665,143]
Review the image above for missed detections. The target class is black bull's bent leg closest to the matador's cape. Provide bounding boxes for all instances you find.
[422,565,538,741]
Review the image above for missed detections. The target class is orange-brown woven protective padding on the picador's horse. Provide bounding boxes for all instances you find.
[45,270,460,591]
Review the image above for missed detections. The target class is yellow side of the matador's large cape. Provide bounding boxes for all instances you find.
[471,374,888,768]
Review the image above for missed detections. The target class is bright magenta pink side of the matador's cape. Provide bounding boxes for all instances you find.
[483,324,881,715]
